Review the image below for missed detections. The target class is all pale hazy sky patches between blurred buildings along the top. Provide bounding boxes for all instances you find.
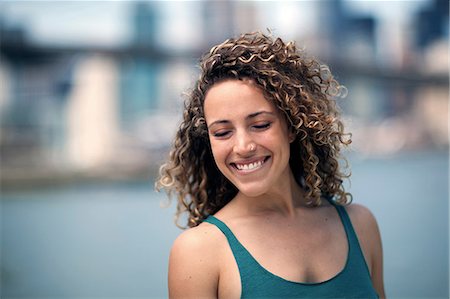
[0,0,431,46]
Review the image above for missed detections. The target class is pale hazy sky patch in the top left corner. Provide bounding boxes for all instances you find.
[0,1,131,45]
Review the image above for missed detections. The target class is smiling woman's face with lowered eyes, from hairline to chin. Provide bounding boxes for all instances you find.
[204,80,294,197]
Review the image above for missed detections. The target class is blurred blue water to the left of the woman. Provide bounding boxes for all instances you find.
[2,182,180,298]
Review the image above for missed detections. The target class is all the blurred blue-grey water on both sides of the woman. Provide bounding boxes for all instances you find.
[1,152,449,298]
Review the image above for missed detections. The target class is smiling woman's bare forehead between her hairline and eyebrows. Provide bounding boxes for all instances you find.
[204,80,277,122]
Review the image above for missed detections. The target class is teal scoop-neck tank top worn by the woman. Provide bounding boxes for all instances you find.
[205,205,378,298]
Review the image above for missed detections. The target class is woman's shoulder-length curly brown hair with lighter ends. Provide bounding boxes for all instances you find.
[156,32,352,227]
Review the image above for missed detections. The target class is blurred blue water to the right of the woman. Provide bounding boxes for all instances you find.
[351,152,449,298]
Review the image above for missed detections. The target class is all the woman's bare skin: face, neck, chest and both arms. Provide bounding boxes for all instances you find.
[169,80,385,298]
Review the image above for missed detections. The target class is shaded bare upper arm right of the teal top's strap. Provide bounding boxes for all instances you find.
[347,204,386,298]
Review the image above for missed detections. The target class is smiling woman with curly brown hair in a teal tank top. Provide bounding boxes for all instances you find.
[157,33,384,298]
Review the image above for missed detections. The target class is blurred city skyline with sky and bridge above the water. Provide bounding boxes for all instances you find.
[0,0,449,188]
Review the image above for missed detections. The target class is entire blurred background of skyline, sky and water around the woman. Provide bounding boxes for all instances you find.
[0,0,449,298]
